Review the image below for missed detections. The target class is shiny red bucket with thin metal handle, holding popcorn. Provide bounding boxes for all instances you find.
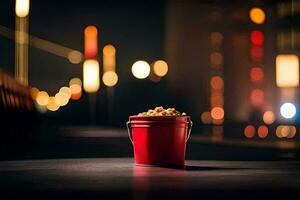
[127,116,192,167]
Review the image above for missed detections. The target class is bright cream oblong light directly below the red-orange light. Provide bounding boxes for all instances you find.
[83,60,100,93]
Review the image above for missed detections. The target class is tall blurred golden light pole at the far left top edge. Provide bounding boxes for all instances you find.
[15,0,30,85]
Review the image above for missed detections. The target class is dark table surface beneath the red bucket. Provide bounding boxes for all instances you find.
[0,158,300,199]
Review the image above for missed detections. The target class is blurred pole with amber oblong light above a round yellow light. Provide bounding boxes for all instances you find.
[102,44,118,124]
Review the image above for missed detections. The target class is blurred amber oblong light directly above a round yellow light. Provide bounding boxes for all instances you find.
[103,44,116,73]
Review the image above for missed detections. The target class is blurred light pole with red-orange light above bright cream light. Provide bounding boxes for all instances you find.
[83,26,100,124]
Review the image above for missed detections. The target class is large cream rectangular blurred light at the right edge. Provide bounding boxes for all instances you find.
[276,55,299,87]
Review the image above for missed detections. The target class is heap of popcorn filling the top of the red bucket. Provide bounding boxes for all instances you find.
[137,106,186,117]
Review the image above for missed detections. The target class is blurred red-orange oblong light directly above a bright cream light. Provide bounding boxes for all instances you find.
[84,26,98,59]
